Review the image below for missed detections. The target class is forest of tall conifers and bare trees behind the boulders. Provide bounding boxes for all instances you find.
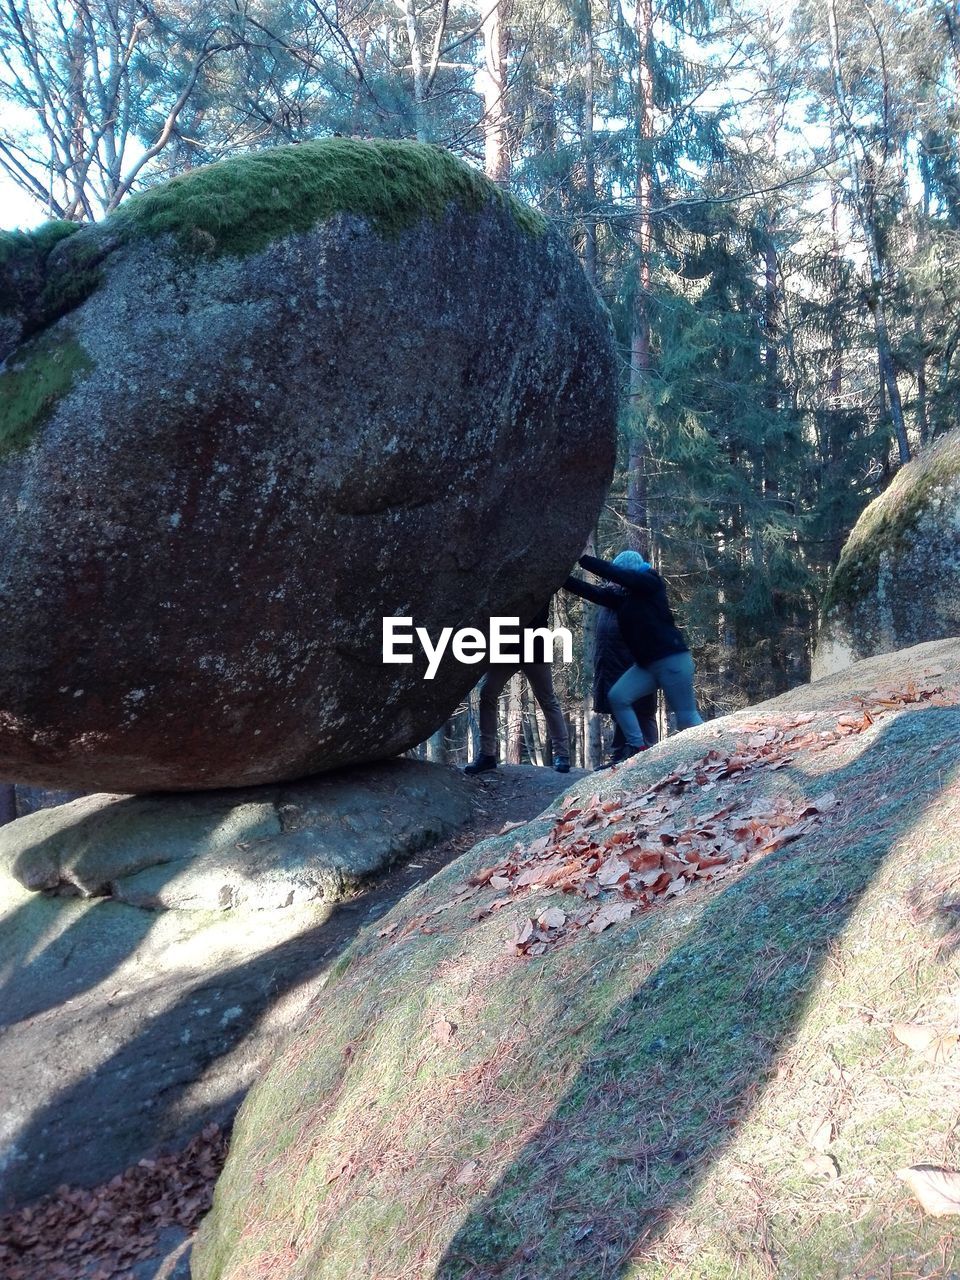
[0,0,960,765]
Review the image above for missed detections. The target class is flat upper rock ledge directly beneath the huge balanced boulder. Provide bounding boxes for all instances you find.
[0,760,471,911]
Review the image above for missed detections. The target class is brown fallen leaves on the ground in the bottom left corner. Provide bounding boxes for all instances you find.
[0,1125,227,1280]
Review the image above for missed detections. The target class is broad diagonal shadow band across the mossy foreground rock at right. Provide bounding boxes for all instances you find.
[435,709,960,1280]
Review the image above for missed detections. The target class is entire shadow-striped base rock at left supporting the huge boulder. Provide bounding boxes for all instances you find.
[0,760,471,1206]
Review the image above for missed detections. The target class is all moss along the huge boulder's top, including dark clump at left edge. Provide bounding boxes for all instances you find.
[0,138,547,358]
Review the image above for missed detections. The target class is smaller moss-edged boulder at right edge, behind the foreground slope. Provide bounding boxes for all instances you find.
[813,431,960,680]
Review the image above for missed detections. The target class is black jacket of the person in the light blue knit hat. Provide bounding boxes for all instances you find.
[563,556,687,667]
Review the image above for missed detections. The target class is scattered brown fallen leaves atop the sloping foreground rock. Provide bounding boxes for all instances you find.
[380,672,956,956]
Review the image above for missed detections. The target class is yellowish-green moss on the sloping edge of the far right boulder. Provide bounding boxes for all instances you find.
[823,431,960,617]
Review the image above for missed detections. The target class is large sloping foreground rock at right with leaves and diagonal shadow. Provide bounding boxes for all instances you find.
[191,641,960,1280]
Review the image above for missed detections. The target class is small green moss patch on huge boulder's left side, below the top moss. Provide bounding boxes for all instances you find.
[0,335,93,458]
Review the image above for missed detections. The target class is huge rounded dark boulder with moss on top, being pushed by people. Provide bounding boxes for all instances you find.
[0,140,616,791]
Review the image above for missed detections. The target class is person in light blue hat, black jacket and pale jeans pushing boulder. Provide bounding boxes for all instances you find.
[564,552,703,758]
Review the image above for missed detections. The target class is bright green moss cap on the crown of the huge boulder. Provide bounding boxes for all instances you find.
[108,138,545,256]
